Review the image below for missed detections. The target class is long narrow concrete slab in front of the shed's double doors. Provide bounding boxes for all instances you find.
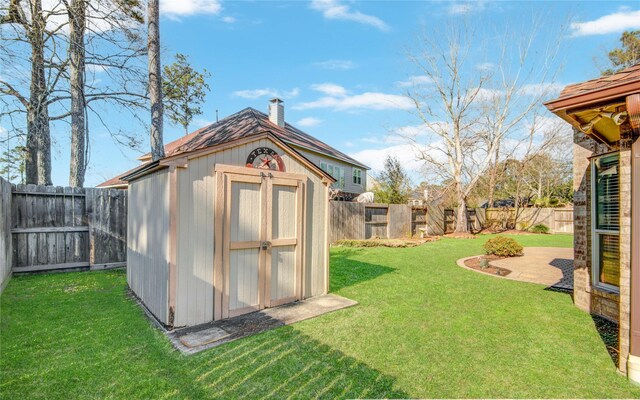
[165,294,358,354]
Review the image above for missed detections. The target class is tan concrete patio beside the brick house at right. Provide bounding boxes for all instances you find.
[458,247,573,290]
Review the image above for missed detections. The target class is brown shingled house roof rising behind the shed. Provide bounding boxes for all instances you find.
[140,107,369,169]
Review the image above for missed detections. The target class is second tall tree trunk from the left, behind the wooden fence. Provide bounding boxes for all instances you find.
[69,0,87,187]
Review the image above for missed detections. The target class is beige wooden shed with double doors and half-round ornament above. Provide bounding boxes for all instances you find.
[121,100,335,327]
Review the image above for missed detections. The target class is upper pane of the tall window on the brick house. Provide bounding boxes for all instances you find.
[594,154,620,231]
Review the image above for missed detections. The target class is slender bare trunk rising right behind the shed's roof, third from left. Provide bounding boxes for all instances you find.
[147,0,164,161]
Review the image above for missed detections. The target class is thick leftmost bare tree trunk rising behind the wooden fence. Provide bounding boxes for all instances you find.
[25,0,51,185]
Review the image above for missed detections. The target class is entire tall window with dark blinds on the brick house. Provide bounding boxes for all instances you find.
[591,153,620,292]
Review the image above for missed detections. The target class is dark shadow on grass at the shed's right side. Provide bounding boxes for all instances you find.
[330,249,396,292]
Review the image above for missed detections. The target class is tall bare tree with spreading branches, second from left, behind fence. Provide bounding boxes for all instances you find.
[58,0,144,186]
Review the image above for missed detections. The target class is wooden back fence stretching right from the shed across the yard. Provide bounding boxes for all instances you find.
[329,201,573,242]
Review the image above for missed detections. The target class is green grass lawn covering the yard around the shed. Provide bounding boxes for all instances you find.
[0,236,640,399]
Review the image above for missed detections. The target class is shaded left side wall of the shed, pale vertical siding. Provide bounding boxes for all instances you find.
[127,170,169,324]
